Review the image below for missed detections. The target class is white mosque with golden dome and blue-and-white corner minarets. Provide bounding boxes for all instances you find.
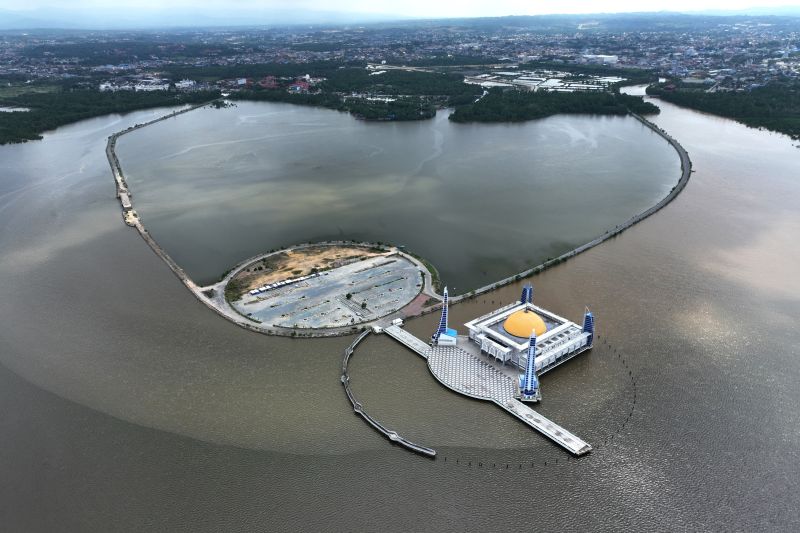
[431,284,594,401]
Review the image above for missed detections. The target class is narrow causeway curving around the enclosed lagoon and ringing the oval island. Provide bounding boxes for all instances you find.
[106,100,692,338]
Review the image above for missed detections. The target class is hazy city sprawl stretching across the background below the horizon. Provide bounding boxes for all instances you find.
[0,15,800,93]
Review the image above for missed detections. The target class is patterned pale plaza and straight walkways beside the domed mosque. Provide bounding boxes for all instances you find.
[383,326,592,455]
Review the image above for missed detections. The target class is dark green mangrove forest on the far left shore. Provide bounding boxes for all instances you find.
[0,90,219,144]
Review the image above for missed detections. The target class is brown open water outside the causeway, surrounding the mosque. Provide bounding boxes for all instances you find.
[0,91,800,531]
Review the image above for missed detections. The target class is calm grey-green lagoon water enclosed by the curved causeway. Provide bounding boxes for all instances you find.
[117,103,680,292]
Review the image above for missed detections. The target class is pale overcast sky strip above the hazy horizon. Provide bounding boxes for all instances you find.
[0,0,800,17]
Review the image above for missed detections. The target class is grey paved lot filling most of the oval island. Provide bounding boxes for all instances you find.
[233,254,423,328]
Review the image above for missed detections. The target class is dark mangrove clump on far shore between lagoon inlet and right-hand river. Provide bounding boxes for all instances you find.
[450,89,659,122]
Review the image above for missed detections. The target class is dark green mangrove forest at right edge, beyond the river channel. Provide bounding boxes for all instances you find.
[647,81,800,139]
